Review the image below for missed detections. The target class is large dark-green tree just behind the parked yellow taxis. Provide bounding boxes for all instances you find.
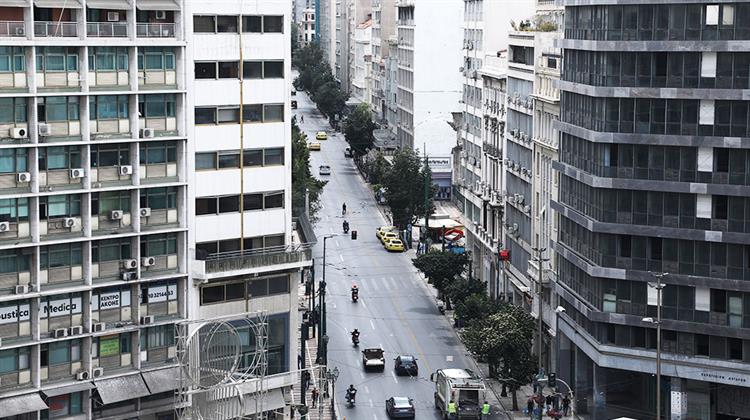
[383,148,437,229]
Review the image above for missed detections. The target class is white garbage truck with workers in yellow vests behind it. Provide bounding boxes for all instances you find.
[430,369,486,419]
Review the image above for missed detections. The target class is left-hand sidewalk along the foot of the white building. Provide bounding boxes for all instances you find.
[293,283,336,420]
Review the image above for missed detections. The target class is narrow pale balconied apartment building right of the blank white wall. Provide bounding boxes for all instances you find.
[455,0,534,298]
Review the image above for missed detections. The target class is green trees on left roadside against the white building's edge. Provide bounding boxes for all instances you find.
[292,121,326,220]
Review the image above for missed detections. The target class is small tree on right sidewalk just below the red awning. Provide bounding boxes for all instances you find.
[412,250,469,309]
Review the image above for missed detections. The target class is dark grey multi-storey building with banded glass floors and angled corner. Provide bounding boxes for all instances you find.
[552,1,750,419]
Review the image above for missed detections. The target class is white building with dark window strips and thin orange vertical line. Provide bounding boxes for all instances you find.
[188,0,312,418]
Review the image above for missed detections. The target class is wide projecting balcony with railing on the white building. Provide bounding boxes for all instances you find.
[193,243,312,279]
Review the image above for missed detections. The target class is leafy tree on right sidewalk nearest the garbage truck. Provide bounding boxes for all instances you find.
[462,303,536,411]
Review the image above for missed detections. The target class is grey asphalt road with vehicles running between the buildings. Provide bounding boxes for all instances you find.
[296,87,499,420]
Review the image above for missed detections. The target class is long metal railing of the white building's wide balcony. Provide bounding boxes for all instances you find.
[204,244,312,273]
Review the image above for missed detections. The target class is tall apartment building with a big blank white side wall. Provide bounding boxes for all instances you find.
[396,0,462,195]
